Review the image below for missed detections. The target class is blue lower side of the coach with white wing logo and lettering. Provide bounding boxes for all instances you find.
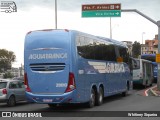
[77,59,132,100]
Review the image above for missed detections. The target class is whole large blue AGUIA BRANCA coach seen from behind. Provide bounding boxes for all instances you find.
[24,30,132,107]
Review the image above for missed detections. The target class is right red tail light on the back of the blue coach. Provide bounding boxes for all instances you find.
[65,73,76,92]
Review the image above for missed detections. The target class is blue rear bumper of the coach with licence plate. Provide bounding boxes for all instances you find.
[26,90,75,104]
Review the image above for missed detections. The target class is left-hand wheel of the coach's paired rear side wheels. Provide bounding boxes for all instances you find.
[87,88,96,108]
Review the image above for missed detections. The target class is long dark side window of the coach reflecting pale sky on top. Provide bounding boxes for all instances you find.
[76,36,116,61]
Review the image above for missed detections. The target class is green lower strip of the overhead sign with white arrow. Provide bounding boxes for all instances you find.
[82,10,121,17]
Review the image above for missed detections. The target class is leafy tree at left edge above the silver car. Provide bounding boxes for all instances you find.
[0,49,16,71]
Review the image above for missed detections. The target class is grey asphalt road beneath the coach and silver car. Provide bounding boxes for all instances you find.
[0,86,160,120]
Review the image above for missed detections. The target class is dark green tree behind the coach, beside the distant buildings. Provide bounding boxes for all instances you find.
[132,41,141,58]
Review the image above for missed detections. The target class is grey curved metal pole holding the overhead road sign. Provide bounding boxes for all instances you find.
[121,9,160,90]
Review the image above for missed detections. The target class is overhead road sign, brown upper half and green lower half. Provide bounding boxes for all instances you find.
[82,4,121,17]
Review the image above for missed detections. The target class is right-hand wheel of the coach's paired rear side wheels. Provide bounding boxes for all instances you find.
[96,87,104,106]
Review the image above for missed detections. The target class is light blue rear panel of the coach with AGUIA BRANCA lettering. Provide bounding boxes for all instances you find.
[25,31,75,103]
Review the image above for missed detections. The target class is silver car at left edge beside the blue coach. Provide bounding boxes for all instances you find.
[0,79,26,107]
